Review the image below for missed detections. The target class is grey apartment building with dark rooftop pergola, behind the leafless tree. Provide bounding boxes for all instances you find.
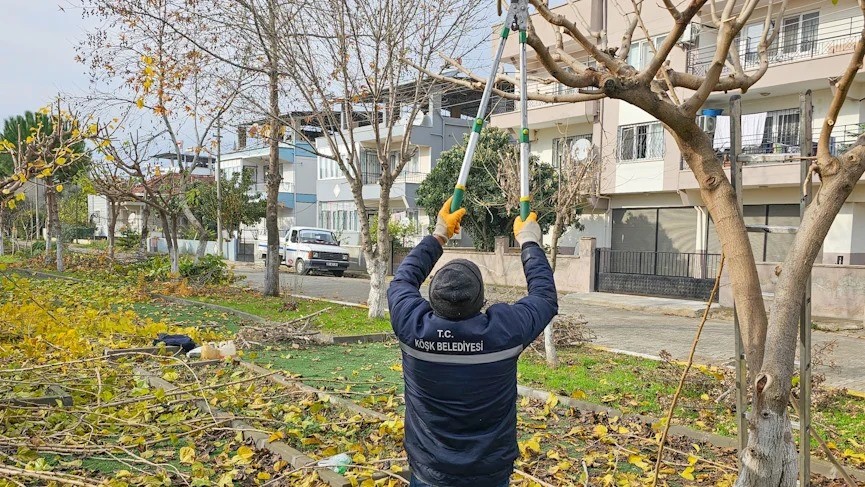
[316,88,490,245]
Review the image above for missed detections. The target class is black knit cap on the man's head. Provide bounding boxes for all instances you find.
[430,259,484,321]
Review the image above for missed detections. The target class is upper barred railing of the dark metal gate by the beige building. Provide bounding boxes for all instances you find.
[597,249,721,279]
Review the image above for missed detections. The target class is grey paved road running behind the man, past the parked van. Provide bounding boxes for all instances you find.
[235,267,865,391]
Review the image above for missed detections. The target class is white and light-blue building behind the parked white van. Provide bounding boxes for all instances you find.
[220,135,316,236]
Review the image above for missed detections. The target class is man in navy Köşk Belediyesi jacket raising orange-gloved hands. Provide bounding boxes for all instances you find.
[388,200,558,487]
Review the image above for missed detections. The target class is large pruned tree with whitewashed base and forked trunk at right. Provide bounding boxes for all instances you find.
[416,0,865,487]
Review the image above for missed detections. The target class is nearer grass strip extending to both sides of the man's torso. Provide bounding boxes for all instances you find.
[254,342,865,467]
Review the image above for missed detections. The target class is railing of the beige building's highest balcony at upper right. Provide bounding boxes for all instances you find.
[686,17,862,76]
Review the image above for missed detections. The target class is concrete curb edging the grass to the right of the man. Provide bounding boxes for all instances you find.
[517,385,865,481]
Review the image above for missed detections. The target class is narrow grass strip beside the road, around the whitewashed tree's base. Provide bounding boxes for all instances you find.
[192,290,391,335]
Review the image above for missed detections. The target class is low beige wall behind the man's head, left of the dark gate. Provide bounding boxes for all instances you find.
[433,237,595,292]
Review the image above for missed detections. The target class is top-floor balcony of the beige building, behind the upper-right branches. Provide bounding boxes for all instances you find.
[686,17,862,76]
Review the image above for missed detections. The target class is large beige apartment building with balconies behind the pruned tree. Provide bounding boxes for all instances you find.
[491,0,865,300]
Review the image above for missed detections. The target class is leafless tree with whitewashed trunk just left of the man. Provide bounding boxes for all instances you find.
[280,0,480,317]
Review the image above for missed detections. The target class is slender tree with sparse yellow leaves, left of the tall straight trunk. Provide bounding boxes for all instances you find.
[78,0,248,264]
